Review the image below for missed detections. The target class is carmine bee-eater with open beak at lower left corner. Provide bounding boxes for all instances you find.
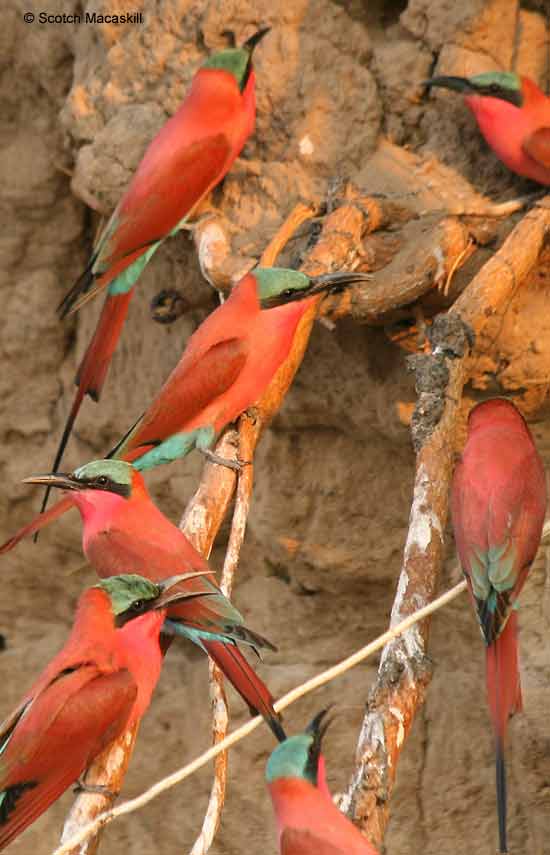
[0,575,213,849]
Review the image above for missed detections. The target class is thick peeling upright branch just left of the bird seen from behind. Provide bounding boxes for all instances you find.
[341,197,550,845]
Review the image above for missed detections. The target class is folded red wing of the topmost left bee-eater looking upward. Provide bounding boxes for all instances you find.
[60,134,231,314]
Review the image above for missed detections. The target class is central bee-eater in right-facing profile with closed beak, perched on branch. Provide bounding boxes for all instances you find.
[109,267,370,470]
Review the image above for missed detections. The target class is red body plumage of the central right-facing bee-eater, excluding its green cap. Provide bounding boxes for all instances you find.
[116,273,315,461]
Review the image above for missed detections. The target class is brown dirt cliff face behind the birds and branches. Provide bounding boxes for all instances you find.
[0,0,550,855]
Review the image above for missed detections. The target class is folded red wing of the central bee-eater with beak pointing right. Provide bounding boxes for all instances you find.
[120,338,249,460]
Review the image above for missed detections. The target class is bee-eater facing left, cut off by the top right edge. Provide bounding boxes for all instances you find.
[426,71,550,185]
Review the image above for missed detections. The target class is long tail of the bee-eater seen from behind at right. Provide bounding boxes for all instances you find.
[487,611,523,852]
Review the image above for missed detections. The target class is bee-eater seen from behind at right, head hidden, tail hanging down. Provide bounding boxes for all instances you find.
[451,398,546,852]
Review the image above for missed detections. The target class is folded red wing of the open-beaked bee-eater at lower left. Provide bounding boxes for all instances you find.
[0,665,137,849]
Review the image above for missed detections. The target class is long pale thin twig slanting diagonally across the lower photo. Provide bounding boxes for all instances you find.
[53,581,467,855]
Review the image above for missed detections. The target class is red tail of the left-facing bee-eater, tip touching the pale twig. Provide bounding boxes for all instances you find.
[203,640,286,742]
